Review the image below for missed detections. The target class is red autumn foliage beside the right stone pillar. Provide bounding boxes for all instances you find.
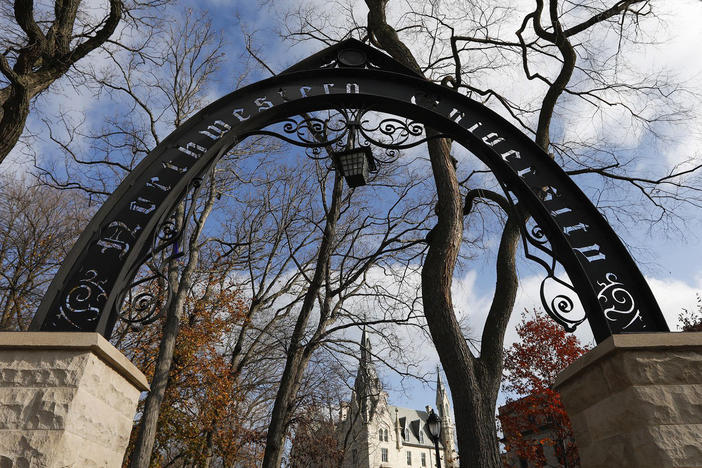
[499,311,589,467]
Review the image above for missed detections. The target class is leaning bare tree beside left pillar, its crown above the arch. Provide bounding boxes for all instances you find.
[26,10,242,467]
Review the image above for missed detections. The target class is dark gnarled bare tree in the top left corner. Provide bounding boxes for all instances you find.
[0,0,169,163]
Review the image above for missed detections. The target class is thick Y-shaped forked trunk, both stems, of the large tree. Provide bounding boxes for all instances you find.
[366,0,519,468]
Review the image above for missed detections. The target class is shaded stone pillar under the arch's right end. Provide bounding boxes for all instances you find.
[555,332,702,468]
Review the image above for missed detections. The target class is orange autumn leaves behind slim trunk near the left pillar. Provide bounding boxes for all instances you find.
[122,287,261,466]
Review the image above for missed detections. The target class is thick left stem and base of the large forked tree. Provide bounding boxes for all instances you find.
[422,134,511,468]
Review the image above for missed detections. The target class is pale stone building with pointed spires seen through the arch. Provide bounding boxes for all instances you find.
[337,331,458,468]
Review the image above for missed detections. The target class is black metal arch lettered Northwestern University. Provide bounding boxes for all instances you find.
[31,40,668,342]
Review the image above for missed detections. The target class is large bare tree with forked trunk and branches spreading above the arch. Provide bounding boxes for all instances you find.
[280,0,701,467]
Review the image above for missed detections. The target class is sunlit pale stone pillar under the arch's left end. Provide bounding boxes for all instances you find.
[0,332,149,468]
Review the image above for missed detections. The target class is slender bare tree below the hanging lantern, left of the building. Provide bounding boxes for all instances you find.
[263,129,430,467]
